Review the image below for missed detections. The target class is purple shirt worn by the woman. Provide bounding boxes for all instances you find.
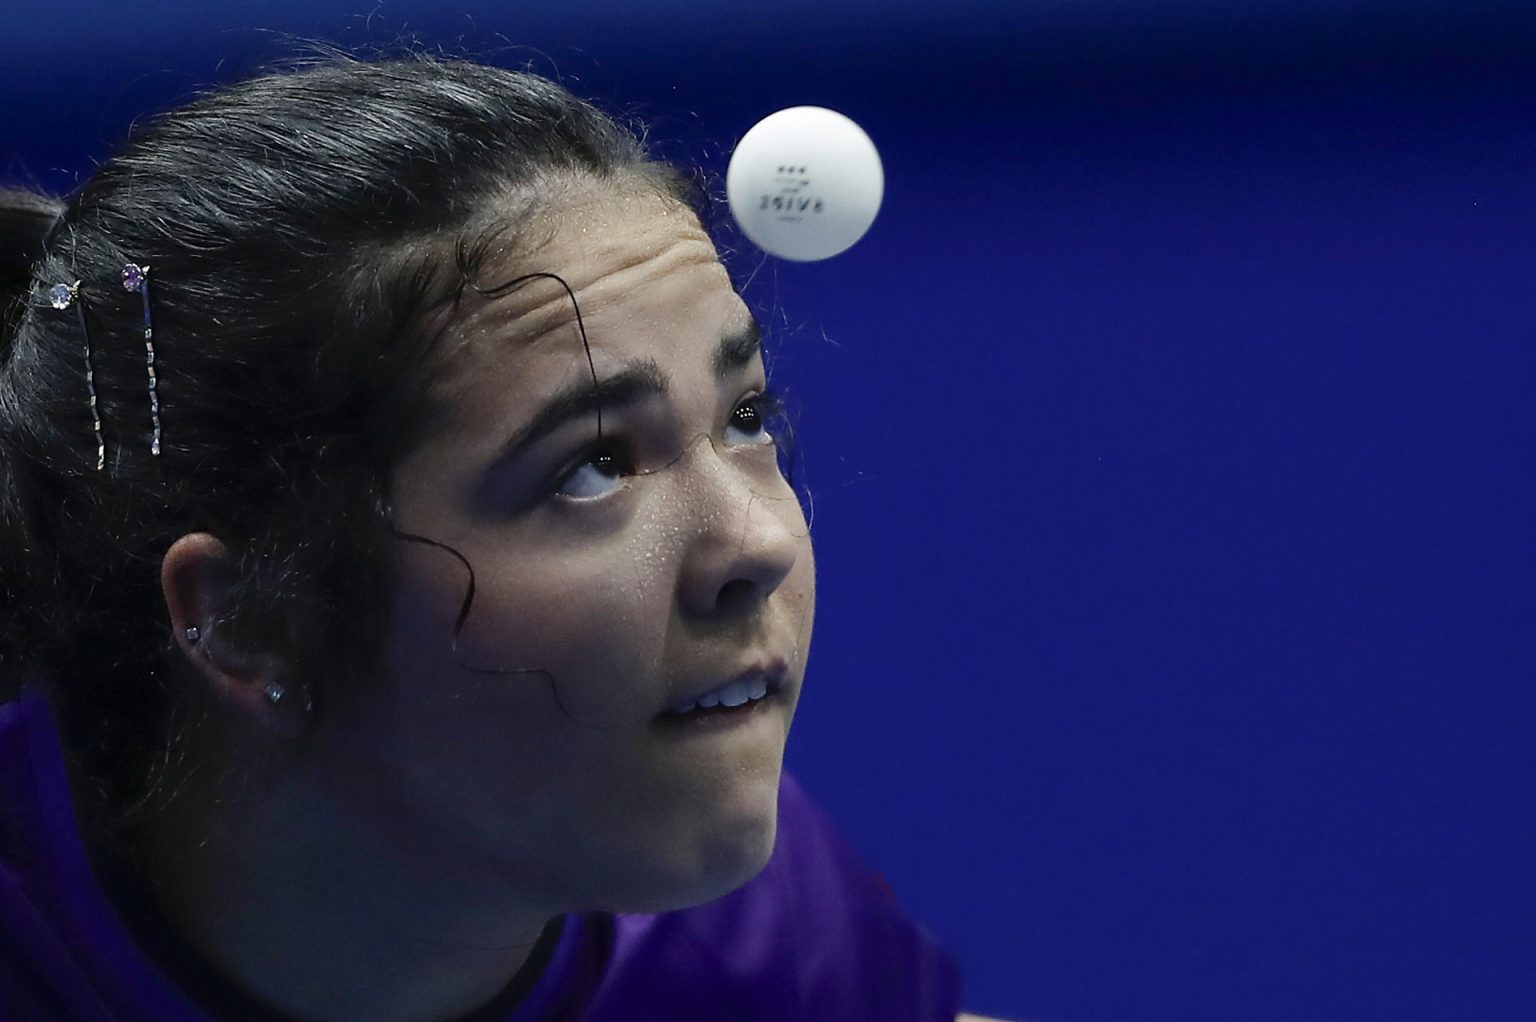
[0,690,960,1022]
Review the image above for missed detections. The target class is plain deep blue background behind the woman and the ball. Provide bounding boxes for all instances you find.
[0,0,1536,1022]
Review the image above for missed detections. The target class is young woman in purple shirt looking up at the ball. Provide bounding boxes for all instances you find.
[0,58,957,1022]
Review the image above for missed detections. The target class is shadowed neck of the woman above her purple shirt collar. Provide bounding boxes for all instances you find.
[143,716,559,1022]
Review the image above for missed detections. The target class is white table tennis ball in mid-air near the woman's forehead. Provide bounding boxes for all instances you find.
[725,106,885,263]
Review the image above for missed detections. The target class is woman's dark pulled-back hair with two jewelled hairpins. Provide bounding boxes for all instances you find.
[0,57,691,848]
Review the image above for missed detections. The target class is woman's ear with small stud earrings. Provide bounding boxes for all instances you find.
[160,532,309,736]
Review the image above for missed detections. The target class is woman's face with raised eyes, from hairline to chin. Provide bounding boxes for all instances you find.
[347,191,814,911]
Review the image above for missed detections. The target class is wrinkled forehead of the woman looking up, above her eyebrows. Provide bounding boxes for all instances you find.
[395,180,753,513]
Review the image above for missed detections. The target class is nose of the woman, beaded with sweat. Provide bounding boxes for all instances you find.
[679,446,803,618]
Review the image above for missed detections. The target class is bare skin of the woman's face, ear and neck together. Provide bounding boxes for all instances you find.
[149,184,814,1022]
